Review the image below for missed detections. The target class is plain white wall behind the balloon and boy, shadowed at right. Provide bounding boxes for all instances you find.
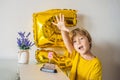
[0,0,120,80]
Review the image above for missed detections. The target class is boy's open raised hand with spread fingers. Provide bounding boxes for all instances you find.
[52,13,69,32]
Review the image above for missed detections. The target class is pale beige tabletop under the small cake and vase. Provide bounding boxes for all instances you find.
[19,64,69,80]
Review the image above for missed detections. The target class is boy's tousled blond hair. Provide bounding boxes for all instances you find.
[70,28,92,48]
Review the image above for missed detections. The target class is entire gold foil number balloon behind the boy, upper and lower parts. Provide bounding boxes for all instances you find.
[33,9,77,72]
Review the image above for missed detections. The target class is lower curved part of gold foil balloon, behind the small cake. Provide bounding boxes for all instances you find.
[35,50,72,69]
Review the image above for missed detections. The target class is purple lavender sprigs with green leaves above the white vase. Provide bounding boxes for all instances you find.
[17,32,34,50]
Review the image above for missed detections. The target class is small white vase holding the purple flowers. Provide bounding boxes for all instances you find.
[18,50,29,64]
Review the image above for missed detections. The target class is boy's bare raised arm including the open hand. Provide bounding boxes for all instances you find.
[52,14,74,53]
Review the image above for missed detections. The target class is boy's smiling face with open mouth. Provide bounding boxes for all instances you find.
[73,34,90,55]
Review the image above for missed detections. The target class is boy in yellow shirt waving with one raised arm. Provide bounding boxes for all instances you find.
[52,14,102,80]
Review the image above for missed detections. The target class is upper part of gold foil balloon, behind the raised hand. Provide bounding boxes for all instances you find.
[33,9,77,48]
